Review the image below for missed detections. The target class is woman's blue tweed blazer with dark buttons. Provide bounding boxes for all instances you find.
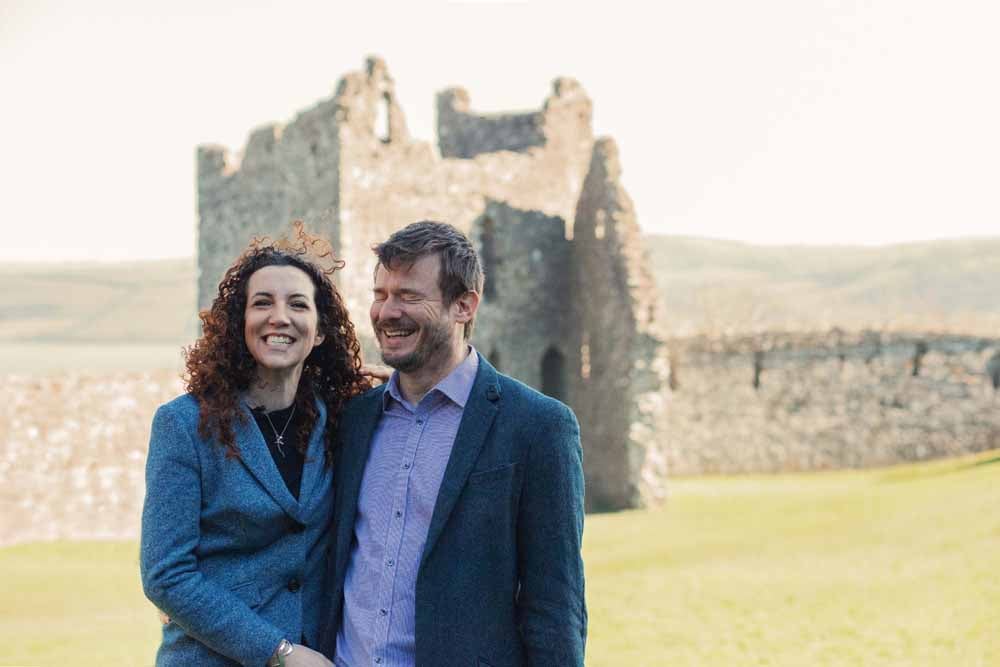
[140,394,333,667]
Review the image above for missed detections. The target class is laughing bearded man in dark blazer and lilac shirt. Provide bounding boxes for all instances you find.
[326,222,587,667]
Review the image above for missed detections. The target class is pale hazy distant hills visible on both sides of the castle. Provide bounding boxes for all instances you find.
[0,235,1000,345]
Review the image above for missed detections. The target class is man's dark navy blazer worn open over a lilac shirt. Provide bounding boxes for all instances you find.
[324,356,587,667]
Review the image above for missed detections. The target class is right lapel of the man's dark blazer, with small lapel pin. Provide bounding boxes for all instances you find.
[420,355,500,567]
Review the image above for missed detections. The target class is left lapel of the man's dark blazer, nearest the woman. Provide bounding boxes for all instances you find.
[334,384,385,581]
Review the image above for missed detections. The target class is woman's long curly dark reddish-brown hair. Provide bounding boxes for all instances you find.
[184,221,371,463]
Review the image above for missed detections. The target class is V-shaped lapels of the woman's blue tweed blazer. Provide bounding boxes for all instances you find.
[233,399,326,523]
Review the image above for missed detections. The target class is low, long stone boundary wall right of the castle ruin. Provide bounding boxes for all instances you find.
[661,331,1000,475]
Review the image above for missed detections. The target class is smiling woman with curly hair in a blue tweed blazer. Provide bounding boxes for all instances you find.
[140,225,370,667]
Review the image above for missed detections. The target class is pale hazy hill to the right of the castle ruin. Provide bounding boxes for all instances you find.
[647,235,1000,335]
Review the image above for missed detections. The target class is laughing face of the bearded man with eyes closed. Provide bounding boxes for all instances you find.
[371,255,462,373]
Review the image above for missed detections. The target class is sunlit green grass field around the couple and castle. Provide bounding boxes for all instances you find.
[0,451,1000,667]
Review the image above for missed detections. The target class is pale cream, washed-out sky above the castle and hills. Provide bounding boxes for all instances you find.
[0,0,1000,261]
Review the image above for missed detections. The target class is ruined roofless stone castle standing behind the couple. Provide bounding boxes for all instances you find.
[198,58,669,511]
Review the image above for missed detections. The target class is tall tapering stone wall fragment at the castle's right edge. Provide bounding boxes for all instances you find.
[573,139,669,509]
